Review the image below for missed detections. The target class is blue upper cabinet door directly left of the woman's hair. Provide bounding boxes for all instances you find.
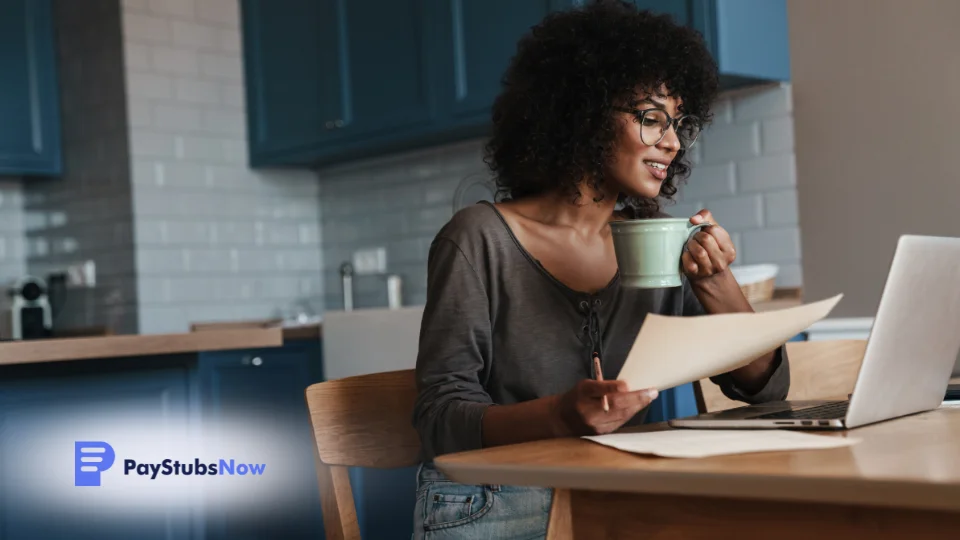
[438,0,562,123]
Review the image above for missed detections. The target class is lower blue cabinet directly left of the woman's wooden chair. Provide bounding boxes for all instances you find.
[198,340,324,540]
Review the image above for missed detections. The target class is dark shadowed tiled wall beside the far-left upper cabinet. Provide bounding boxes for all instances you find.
[23,0,138,333]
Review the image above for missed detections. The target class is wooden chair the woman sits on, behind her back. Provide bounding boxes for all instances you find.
[305,370,420,540]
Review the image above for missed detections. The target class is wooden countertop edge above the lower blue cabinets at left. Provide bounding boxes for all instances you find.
[0,328,284,365]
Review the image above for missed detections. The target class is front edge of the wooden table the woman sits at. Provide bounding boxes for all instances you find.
[435,456,960,512]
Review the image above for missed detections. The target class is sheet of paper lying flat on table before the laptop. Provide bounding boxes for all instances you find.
[584,429,860,458]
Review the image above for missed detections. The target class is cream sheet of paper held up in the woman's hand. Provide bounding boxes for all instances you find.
[617,294,843,390]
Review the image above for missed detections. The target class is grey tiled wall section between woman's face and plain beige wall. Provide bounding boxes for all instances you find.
[667,85,802,287]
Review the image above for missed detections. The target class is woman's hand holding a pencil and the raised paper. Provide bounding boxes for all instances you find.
[557,379,657,436]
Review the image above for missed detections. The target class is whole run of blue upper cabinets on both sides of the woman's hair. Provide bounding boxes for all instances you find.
[242,0,790,167]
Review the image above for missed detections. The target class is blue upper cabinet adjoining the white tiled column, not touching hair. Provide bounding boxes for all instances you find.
[242,0,436,166]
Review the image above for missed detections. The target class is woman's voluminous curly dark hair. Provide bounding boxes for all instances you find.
[484,0,718,217]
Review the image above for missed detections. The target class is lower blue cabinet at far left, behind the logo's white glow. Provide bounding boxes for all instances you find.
[0,356,199,540]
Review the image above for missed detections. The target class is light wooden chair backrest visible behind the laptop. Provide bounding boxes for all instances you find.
[694,339,867,412]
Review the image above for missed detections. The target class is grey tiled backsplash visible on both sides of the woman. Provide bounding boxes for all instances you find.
[319,85,801,309]
